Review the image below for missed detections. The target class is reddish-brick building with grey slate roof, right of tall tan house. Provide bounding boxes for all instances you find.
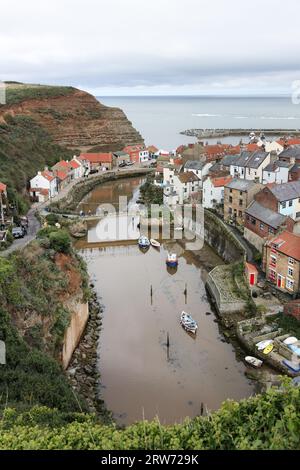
[244,200,294,253]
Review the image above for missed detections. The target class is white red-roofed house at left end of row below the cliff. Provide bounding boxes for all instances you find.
[29,168,58,202]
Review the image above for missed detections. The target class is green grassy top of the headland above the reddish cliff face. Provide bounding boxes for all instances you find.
[5,82,75,106]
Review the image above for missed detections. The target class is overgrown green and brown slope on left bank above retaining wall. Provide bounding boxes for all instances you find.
[0,227,89,412]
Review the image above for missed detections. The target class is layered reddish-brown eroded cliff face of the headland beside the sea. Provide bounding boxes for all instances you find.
[0,85,143,152]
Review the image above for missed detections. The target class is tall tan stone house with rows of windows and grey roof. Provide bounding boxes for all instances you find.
[224,178,262,225]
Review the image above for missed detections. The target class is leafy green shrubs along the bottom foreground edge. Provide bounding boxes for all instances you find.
[0,386,300,450]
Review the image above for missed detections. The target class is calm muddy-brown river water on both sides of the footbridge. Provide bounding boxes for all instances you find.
[77,178,254,424]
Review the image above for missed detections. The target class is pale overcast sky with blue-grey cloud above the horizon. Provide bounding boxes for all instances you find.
[0,0,300,96]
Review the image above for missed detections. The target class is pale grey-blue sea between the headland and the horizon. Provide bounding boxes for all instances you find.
[97,96,300,150]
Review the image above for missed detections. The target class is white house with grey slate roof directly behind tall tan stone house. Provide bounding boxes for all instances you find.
[230,150,271,183]
